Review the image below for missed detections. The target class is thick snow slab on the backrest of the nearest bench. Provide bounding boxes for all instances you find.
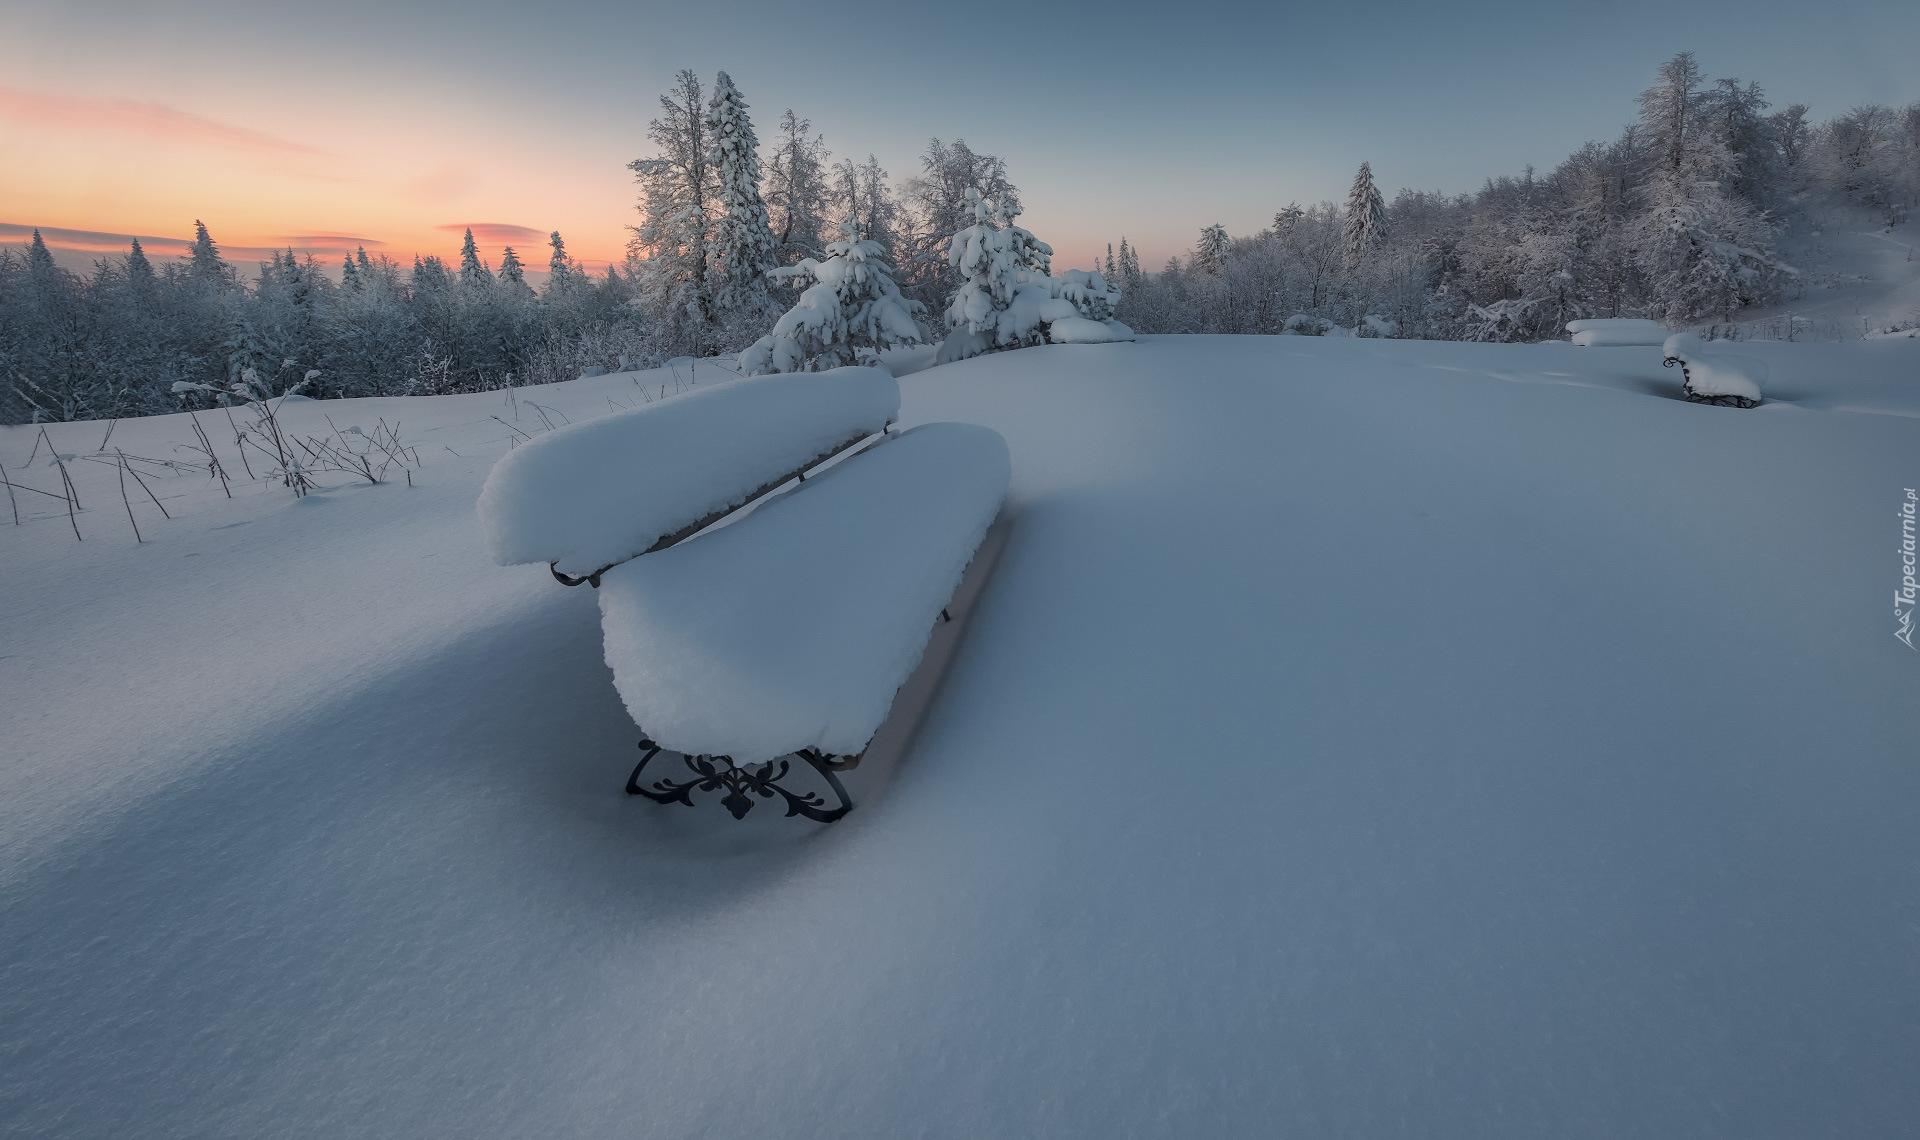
[480,368,900,576]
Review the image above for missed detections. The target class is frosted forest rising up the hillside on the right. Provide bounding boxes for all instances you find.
[1102,54,1920,342]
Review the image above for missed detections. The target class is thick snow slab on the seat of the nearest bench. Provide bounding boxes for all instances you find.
[599,424,1012,764]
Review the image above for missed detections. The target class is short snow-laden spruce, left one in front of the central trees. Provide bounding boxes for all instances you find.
[739,215,927,376]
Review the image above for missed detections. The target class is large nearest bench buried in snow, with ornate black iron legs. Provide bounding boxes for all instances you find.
[480,368,1012,821]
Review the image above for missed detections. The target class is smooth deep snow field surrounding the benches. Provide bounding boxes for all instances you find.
[0,338,1920,1140]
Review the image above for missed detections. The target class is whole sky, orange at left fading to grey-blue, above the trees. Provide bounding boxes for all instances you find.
[0,0,1920,280]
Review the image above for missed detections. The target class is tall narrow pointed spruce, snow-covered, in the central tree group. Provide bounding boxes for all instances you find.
[707,71,778,322]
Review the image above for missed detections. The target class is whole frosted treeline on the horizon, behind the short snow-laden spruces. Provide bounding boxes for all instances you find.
[0,54,1920,422]
